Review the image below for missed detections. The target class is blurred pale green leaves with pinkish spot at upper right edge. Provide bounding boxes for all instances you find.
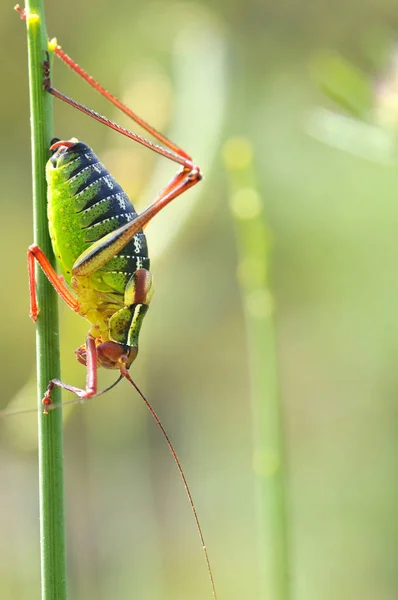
[307,44,398,163]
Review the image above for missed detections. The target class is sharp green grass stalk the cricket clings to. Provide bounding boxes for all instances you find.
[22,0,66,600]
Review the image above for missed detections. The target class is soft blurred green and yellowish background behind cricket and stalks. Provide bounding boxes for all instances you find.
[0,0,398,600]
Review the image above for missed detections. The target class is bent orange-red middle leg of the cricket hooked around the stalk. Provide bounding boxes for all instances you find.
[28,244,79,322]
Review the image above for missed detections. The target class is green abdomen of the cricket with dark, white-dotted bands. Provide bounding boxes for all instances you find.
[47,141,149,294]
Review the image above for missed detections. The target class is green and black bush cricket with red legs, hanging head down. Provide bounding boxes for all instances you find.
[16,7,216,598]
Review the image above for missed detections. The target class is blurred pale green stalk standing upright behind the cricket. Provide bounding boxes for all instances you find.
[224,138,289,600]
